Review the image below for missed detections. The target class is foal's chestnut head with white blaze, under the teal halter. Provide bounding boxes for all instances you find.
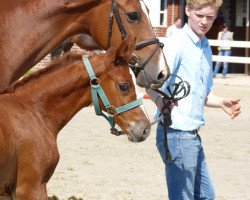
[94,37,150,142]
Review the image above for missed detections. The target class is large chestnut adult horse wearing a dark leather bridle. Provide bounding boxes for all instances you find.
[0,0,169,88]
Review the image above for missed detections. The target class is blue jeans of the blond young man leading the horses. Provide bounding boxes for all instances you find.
[156,123,215,200]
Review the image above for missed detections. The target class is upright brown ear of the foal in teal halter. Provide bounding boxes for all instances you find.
[115,35,136,62]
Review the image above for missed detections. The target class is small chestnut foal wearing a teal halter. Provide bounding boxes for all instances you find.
[0,37,150,200]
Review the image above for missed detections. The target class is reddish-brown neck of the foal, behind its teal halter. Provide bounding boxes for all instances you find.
[17,54,107,134]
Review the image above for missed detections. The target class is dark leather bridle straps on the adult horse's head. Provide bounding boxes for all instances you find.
[107,0,164,76]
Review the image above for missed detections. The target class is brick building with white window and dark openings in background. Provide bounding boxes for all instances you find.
[144,0,250,74]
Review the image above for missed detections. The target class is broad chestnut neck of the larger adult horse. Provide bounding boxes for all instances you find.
[0,0,93,88]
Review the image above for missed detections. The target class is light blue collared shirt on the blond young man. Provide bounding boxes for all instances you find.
[155,24,213,131]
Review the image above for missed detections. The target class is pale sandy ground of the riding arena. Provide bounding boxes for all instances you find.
[47,75,250,200]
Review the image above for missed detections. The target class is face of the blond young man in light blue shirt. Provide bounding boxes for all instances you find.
[185,5,217,39]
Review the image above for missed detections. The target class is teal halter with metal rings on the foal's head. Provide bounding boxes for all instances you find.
[82,58,142,131]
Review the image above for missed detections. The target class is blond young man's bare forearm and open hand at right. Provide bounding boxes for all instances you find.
[205,92,241,119]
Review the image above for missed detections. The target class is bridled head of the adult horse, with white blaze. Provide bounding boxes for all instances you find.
[82,0,169,88]
